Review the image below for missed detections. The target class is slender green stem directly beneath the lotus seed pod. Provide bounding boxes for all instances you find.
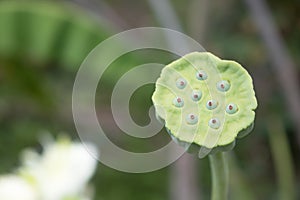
[209,152,228,200]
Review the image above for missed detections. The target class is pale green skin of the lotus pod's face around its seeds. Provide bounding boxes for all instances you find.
[152,52,257,152]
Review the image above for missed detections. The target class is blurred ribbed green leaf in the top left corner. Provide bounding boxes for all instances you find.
[0,1,109,69]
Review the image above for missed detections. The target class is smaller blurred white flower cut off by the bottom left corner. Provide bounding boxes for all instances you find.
[0,175,39,200]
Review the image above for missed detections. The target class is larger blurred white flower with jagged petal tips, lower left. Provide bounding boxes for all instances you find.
[19,136,97,200]
